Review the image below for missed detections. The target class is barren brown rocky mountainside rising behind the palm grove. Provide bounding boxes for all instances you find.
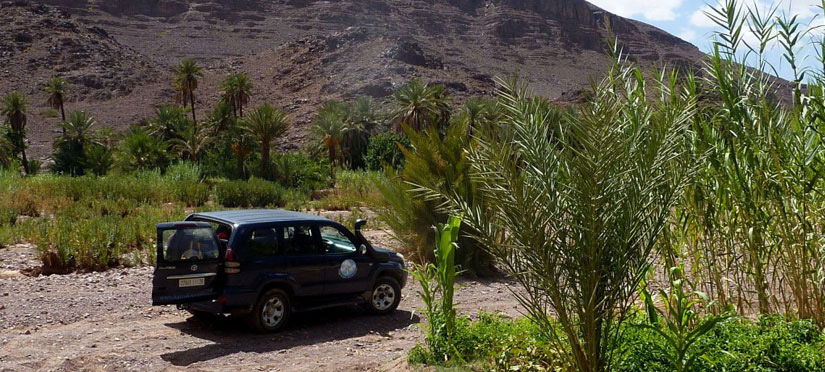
[0,0,702,155]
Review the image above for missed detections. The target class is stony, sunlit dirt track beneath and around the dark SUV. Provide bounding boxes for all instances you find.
[0,245,518,371]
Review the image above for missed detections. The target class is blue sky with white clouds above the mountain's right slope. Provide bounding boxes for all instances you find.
[588,0,823,78]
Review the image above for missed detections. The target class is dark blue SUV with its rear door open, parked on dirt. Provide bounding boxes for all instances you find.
[152,210,407,332]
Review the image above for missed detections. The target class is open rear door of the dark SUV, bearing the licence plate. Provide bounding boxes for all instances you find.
[152,221,223,305]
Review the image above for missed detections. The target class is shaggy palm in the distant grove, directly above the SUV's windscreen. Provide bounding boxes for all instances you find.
[311,101,349,166]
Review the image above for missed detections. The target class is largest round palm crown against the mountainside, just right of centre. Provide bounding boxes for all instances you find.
[390,80,450,130]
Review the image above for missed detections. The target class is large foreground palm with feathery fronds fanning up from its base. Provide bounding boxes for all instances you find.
[412,58,695,372]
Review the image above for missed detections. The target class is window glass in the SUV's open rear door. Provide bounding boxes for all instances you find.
[162,227,220,262]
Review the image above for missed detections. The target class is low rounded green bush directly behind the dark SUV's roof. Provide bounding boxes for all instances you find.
[215,177,283,208]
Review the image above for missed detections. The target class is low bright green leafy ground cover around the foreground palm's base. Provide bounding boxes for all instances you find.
[408,312,825,372]
